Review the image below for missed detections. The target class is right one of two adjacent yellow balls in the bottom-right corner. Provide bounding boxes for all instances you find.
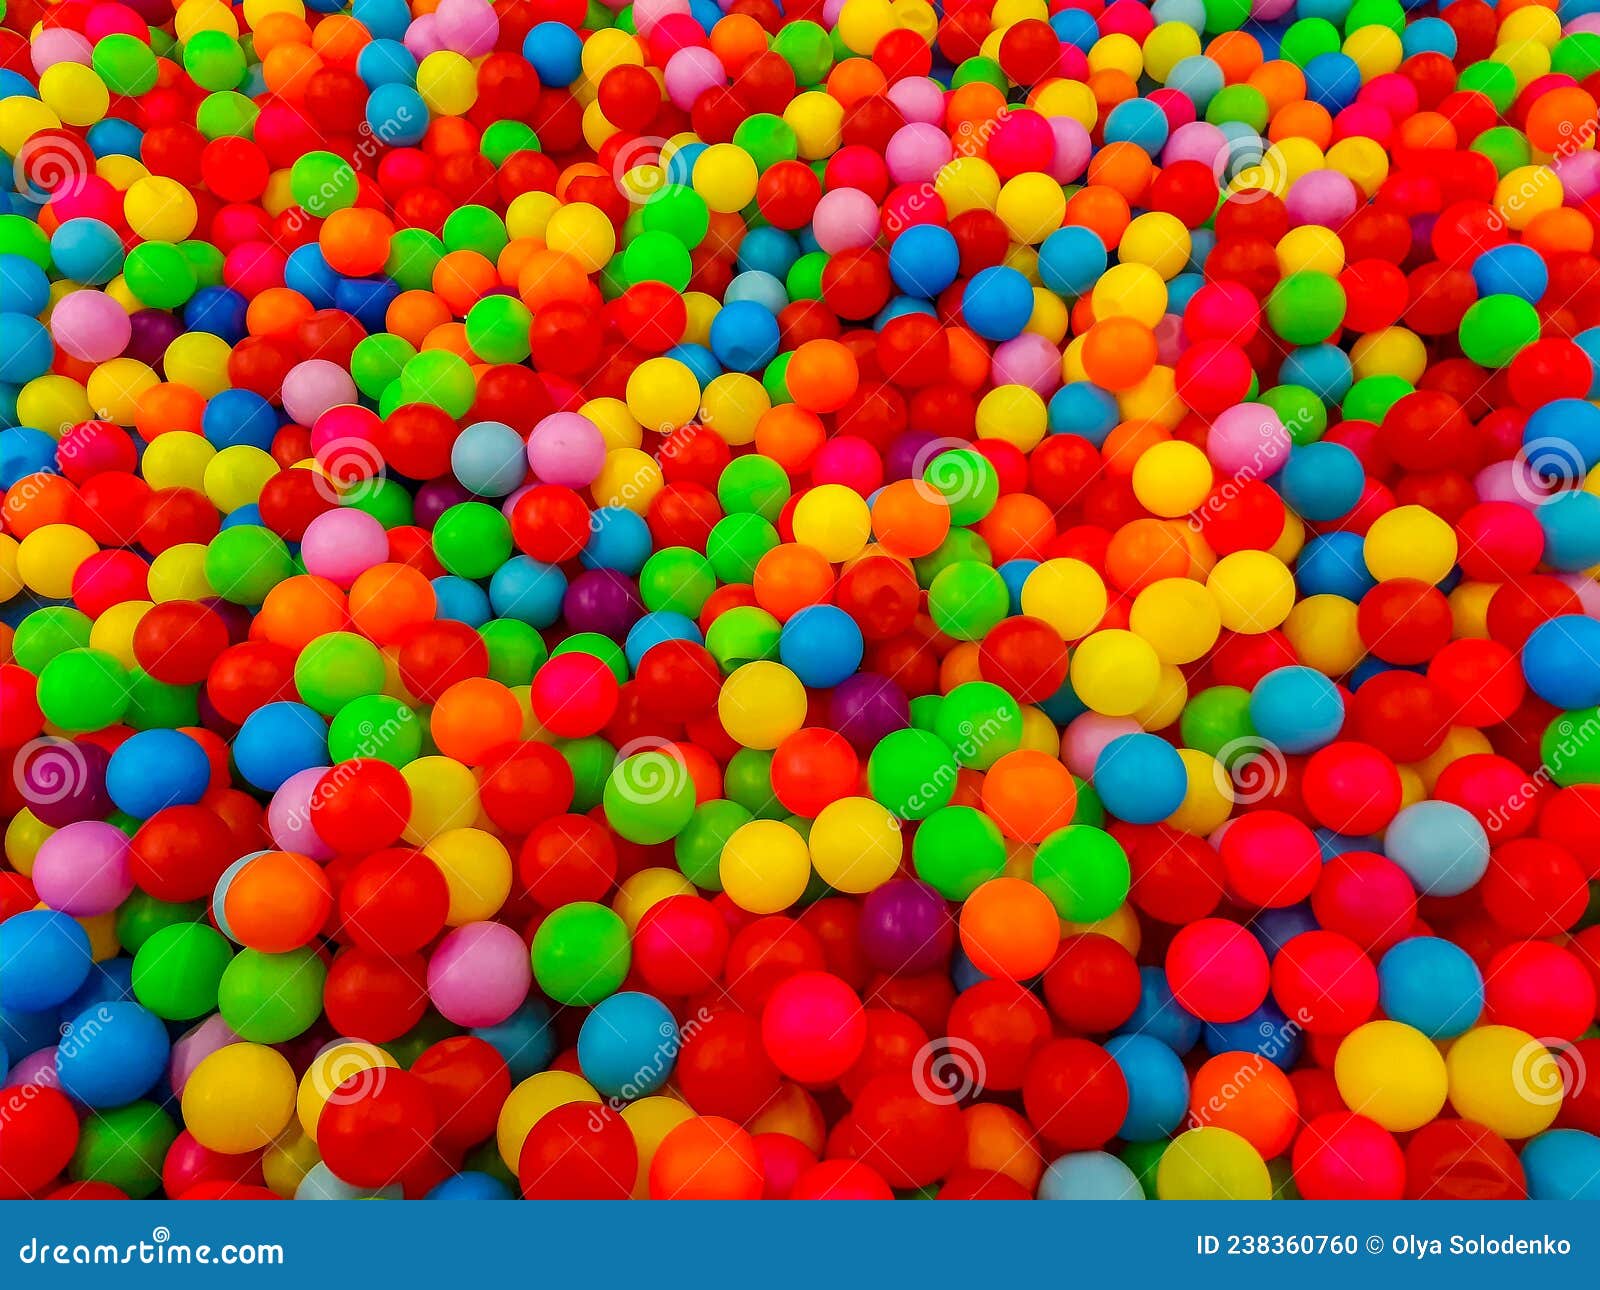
[1445,1026,1563,1141]
